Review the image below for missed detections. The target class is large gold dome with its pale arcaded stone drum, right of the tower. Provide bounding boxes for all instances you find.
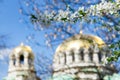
[53,34,115,80]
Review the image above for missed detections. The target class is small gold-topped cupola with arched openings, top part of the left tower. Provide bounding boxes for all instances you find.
[9,44,34,72]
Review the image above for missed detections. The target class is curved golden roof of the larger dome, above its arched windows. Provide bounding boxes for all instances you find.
[56,34,105,53]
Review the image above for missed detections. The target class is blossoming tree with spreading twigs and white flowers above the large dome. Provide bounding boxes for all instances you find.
[19,0,120,79]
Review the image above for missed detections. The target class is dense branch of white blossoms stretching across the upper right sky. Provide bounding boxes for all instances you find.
[32,0,120,26]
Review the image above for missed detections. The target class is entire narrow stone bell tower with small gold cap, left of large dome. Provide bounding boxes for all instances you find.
[5,44,40,80]
